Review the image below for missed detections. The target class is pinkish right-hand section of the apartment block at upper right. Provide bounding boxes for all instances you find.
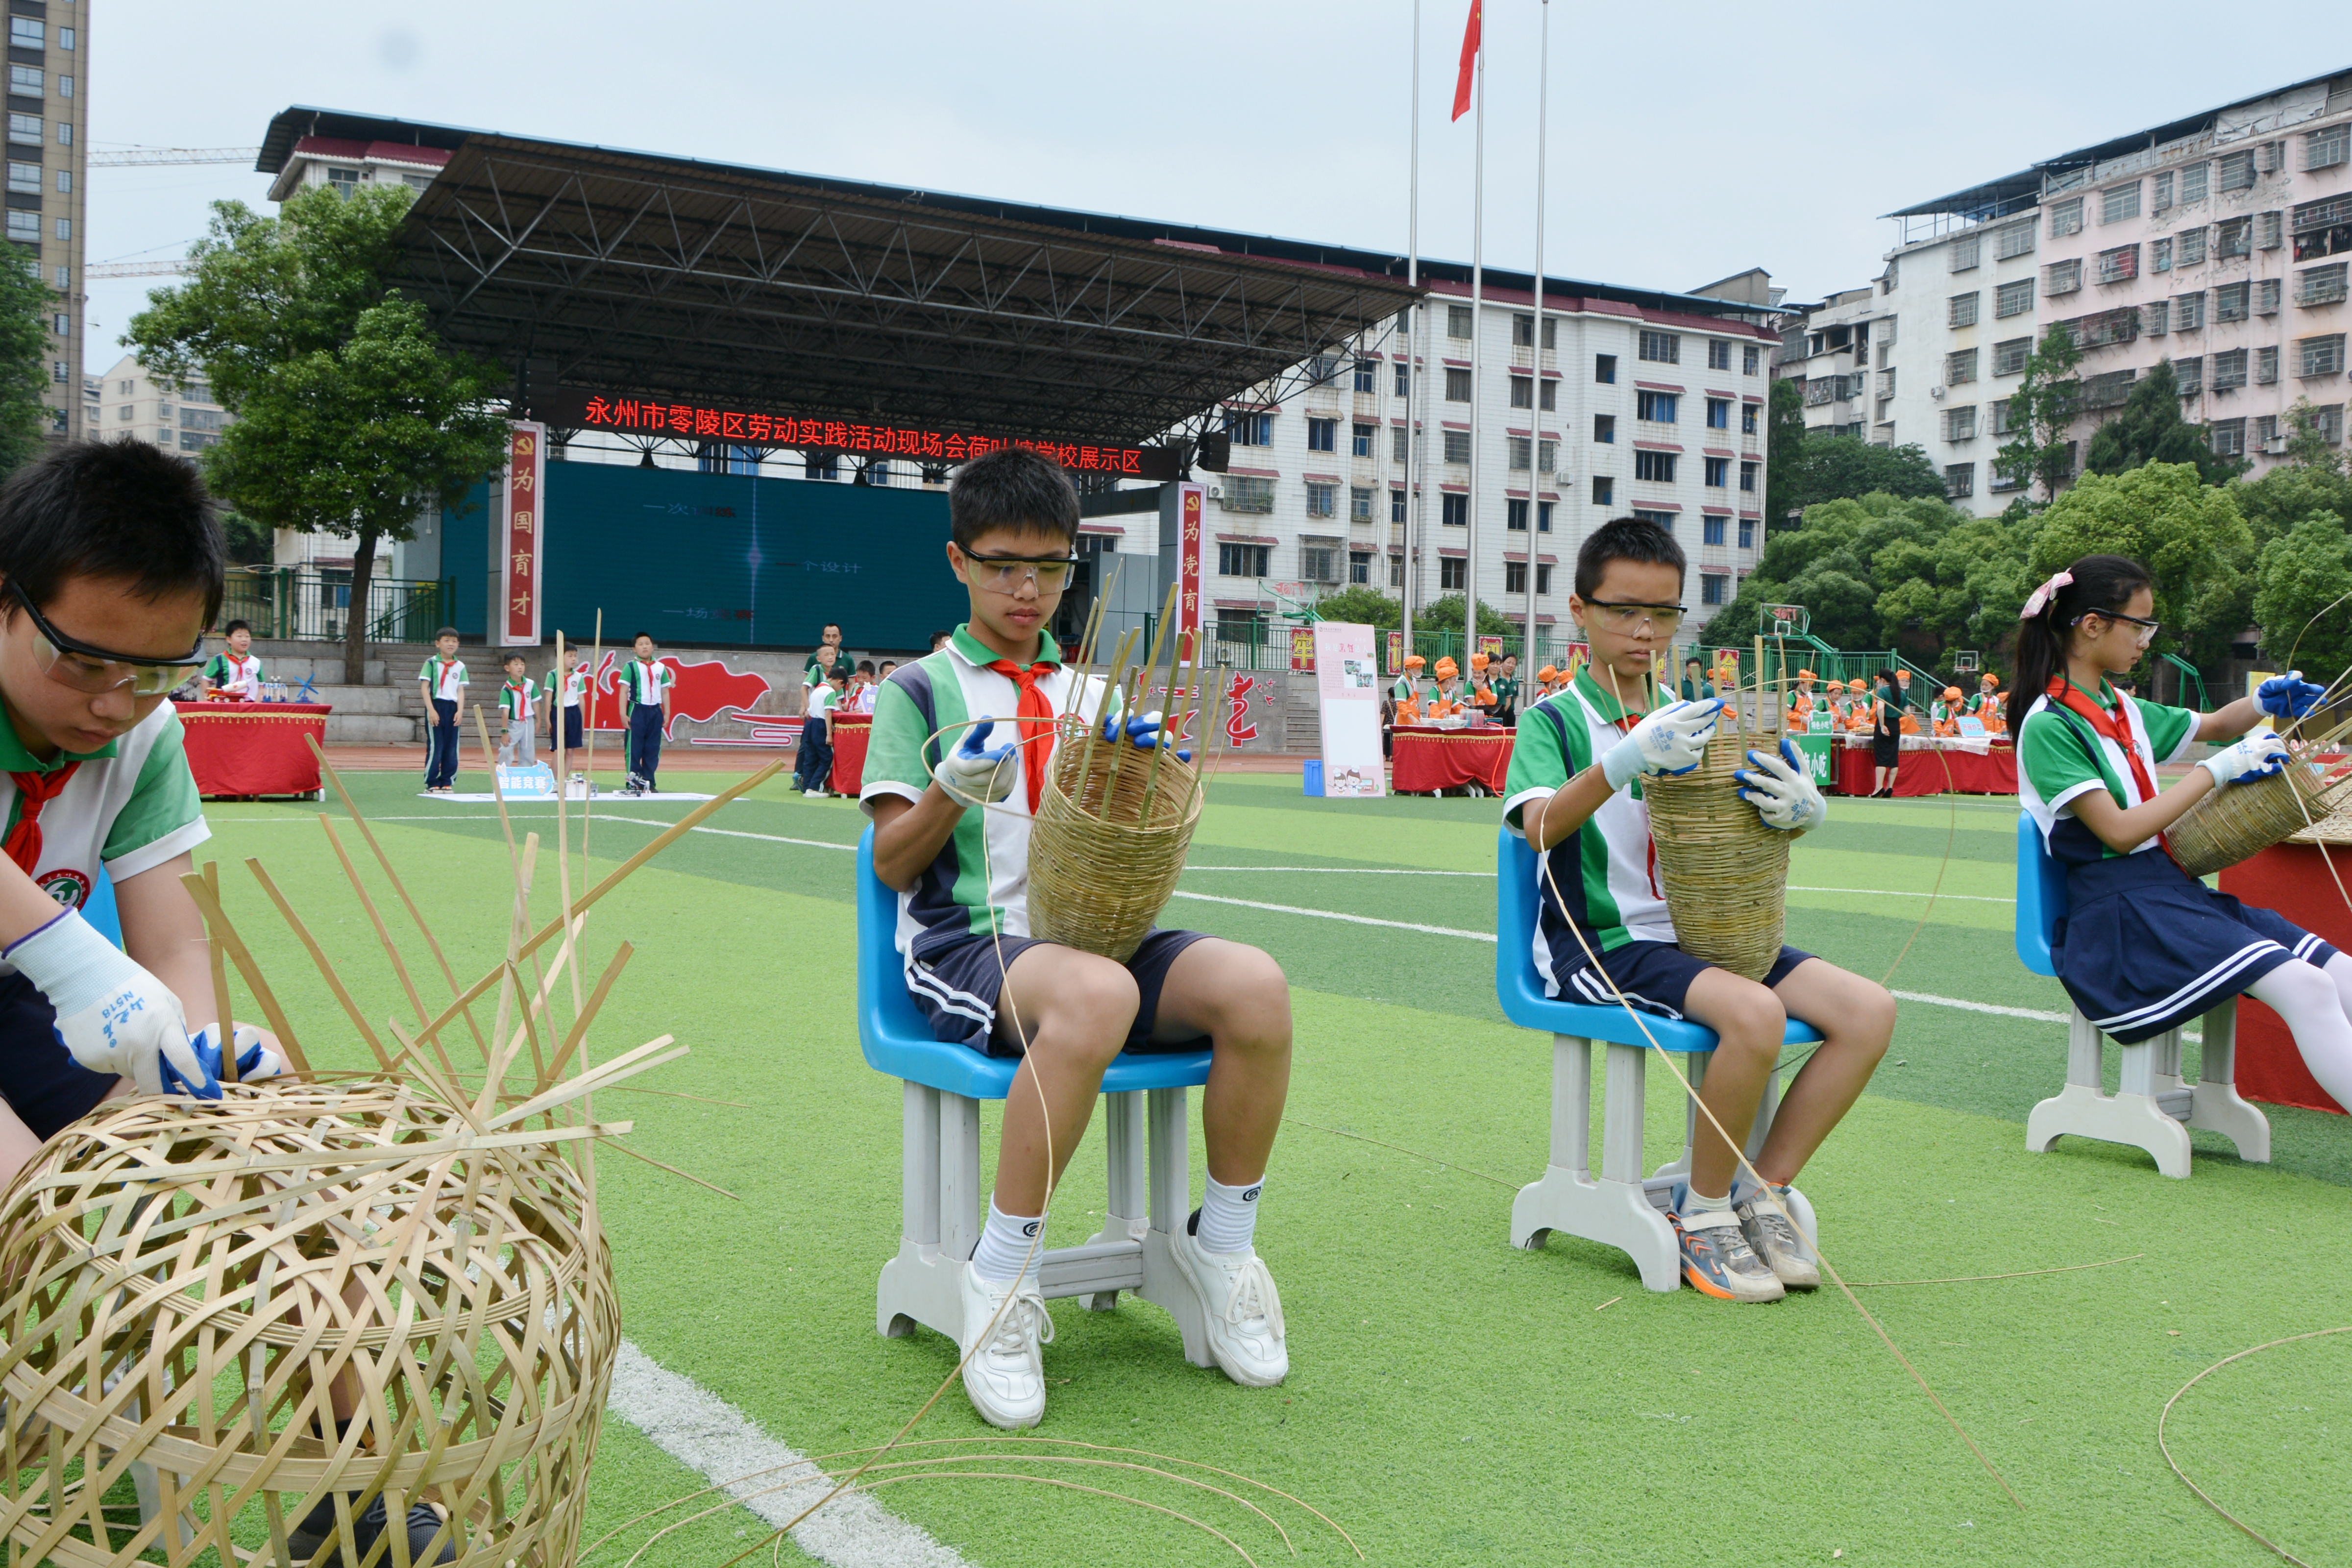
[2032,75,2352,470]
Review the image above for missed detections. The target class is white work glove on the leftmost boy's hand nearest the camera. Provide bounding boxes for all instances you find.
[0,910,221,1100]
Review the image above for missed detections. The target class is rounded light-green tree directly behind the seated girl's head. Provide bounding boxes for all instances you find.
[2028,463,2253,686]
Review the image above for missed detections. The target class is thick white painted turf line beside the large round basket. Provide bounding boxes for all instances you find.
[605,1340,971,1568]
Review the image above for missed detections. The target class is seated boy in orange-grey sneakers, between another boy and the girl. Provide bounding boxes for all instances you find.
[1503,517,1896,1302]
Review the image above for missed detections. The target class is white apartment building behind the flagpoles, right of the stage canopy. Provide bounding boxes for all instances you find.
[1200,263,1778,639]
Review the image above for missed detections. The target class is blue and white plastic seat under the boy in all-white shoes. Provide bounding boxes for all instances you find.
[858,828,1214,1366]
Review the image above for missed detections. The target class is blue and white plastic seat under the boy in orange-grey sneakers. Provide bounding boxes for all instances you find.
[1494,828,1820,1291]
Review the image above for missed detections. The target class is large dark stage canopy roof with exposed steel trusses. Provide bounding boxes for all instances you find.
[256,108,1418,453]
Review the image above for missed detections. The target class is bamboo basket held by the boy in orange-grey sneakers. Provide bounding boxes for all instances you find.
[1642,731,1790,980]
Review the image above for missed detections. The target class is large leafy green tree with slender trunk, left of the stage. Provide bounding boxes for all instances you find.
[124,186,508,684]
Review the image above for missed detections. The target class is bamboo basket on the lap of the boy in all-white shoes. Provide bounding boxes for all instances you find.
[1028,726,1202,964]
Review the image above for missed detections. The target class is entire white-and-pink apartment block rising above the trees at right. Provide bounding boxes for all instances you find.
[1778,73,2352,515]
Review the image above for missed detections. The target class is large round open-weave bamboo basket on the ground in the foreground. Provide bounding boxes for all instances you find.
[0,1079,621,1568]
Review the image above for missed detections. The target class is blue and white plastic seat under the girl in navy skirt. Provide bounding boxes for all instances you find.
[2018,811,2270,1178]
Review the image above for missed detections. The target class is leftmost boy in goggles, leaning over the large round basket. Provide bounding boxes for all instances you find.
[0,442,280,1182]
